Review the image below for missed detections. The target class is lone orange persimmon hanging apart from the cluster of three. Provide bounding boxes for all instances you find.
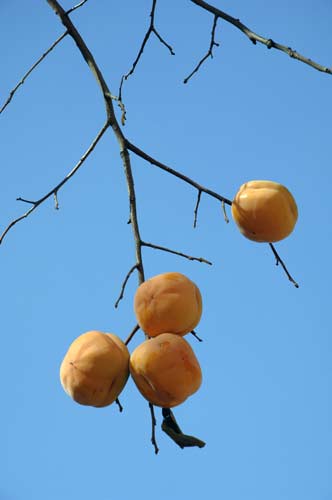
[232,181,298,243]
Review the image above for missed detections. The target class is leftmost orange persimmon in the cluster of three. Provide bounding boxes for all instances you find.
[60,330,130,408]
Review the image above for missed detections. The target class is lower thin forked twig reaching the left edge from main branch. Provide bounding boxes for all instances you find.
[0,122,109,245]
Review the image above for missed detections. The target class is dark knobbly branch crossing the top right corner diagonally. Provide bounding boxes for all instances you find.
[191,0,332,75]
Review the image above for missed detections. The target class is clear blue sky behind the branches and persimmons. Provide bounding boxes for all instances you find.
[0,0,332,500]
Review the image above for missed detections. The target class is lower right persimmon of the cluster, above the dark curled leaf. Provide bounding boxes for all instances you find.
[129,333,202,408]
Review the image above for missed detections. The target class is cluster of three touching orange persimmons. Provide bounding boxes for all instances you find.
[60,273,202,408]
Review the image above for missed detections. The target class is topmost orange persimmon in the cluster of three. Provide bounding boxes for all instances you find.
[134,273,202,337]
